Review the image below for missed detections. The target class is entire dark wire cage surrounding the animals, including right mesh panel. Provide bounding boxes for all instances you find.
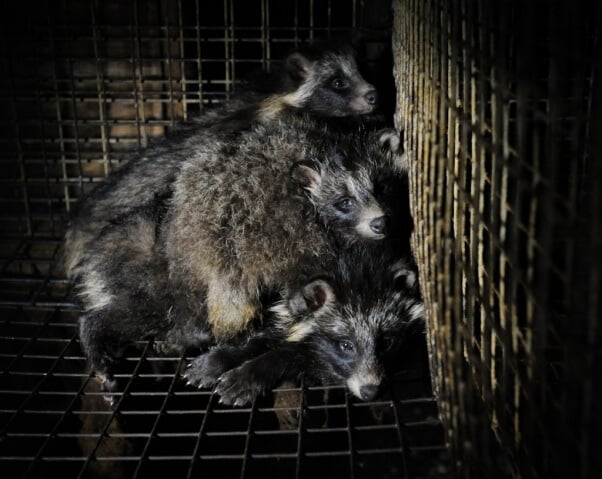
[0,0,602,478]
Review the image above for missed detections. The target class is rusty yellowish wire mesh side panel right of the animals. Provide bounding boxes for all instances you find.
[393,0,602,478]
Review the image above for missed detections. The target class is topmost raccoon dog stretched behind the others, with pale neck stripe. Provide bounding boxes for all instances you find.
[63,43,378,282]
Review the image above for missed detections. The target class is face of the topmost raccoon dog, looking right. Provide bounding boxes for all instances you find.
[286,45,378,117]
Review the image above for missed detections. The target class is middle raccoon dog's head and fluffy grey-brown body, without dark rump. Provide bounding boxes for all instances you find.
[166,117,387,340]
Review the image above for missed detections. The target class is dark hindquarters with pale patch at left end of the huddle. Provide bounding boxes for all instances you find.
[76,198,211,376]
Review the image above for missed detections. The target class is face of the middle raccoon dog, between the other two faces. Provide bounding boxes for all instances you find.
[292,156,387,244]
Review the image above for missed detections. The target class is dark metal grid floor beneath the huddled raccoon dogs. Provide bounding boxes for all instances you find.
[0,238,450,478]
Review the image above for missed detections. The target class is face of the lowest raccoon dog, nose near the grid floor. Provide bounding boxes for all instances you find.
[273,255,424,401]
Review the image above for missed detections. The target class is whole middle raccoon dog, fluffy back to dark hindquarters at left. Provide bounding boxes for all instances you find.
[76,117,387,382]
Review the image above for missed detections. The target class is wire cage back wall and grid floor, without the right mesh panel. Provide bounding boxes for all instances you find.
[0,0,451,478]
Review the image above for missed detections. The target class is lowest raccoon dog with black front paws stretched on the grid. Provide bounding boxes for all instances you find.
[185,248,424,406]
